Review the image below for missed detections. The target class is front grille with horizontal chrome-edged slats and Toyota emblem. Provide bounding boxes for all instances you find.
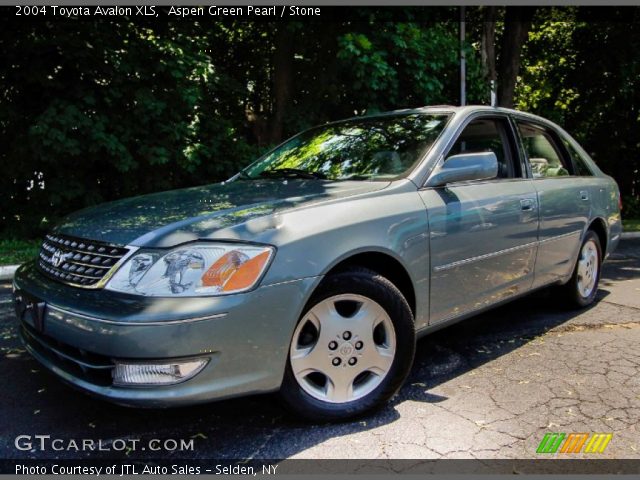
[38,235,129,288]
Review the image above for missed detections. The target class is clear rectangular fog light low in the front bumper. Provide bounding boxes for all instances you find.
[112,358,209,386]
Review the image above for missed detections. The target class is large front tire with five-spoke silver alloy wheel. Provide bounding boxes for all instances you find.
[280,268,416,421]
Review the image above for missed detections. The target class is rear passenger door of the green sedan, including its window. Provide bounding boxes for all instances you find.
[515,118,593,287]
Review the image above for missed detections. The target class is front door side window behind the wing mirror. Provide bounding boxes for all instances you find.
[447,118,514,178]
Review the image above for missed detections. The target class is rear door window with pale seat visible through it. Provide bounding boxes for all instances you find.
[517,122,570,178]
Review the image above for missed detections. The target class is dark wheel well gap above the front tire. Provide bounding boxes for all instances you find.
[327,252,416,318]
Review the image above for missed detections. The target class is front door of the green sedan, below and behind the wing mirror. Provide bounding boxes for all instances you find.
[420,114,538,323]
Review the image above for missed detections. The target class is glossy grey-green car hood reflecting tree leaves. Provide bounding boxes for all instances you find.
[54,180,389,247]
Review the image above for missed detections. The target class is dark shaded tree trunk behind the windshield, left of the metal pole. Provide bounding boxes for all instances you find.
[269,25,294,143]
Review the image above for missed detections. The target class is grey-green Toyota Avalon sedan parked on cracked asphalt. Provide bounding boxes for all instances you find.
[14,106,621,420]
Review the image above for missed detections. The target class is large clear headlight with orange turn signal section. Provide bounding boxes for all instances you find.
[105,243,273,297]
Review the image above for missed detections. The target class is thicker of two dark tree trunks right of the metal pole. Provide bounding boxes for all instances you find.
[498,7,535,108]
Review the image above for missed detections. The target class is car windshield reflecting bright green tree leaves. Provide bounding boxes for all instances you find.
[239,114,449,180]
